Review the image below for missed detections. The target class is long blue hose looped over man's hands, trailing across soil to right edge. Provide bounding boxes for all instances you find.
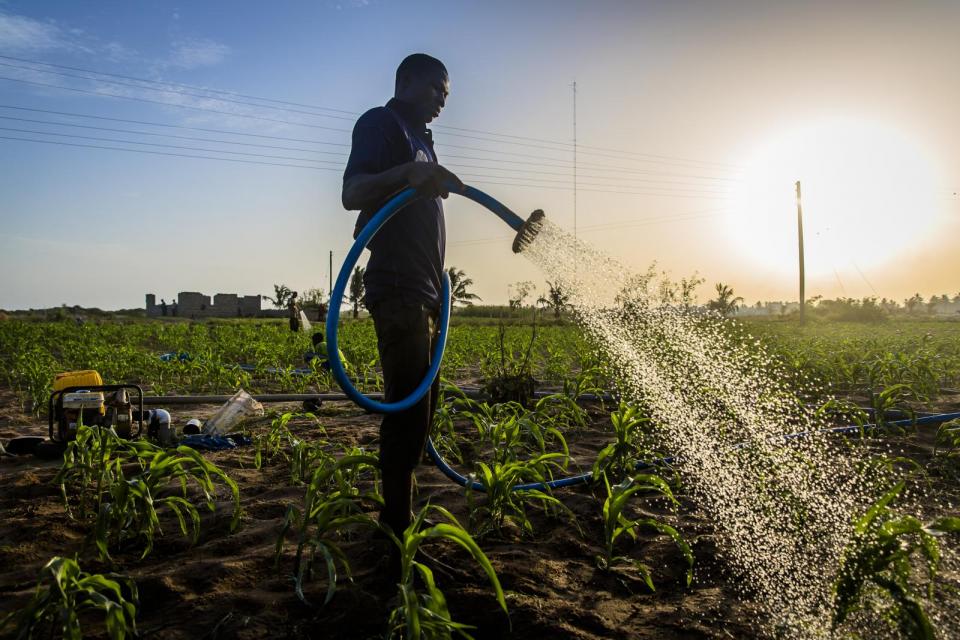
[327,186,960,492]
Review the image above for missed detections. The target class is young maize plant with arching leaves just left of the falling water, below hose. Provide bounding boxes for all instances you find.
[597,473,693,591]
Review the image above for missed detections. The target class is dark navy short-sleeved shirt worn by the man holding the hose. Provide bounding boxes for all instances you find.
[343,98,446,308]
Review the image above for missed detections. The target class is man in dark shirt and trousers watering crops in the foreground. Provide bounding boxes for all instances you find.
[343,53,463,536]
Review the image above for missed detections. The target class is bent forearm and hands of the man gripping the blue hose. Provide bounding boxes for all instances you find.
[341,162,463,211]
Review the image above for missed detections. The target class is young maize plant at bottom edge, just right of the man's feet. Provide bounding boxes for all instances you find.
[387,504,509,640]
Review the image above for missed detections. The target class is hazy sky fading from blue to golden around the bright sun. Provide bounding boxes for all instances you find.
[0,0,960,309]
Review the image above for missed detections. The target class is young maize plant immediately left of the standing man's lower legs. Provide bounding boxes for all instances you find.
[274,449,383,605]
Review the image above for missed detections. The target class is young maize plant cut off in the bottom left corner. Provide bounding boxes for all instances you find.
[0,556,140,640]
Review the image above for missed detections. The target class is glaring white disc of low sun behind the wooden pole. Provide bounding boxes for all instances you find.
[727,119,939,276]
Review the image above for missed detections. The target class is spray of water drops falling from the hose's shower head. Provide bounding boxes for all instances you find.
[524,222,879,637]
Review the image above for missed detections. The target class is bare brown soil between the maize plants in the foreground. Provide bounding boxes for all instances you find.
[0,388,776,638]
